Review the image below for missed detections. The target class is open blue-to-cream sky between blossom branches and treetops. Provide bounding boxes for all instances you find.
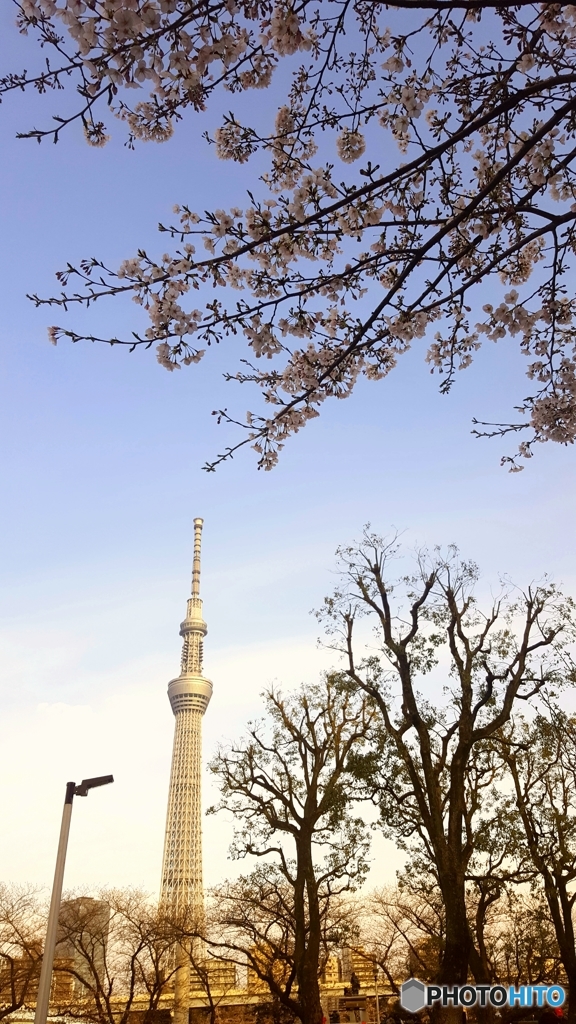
[0,4,576,905]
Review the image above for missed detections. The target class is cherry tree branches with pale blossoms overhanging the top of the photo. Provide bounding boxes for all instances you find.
[5,0,576,468]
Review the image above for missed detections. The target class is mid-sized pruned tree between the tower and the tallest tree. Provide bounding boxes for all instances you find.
[203,674,374,1024]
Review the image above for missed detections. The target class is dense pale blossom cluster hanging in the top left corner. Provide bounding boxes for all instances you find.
[13,0,316,145]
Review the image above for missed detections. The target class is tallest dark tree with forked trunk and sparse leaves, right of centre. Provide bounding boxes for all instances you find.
[321,531,576,995]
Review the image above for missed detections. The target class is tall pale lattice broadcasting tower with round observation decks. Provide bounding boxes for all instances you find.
[161,519,212,915]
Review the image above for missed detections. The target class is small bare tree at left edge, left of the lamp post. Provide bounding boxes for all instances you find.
[0,883,45,1020]
